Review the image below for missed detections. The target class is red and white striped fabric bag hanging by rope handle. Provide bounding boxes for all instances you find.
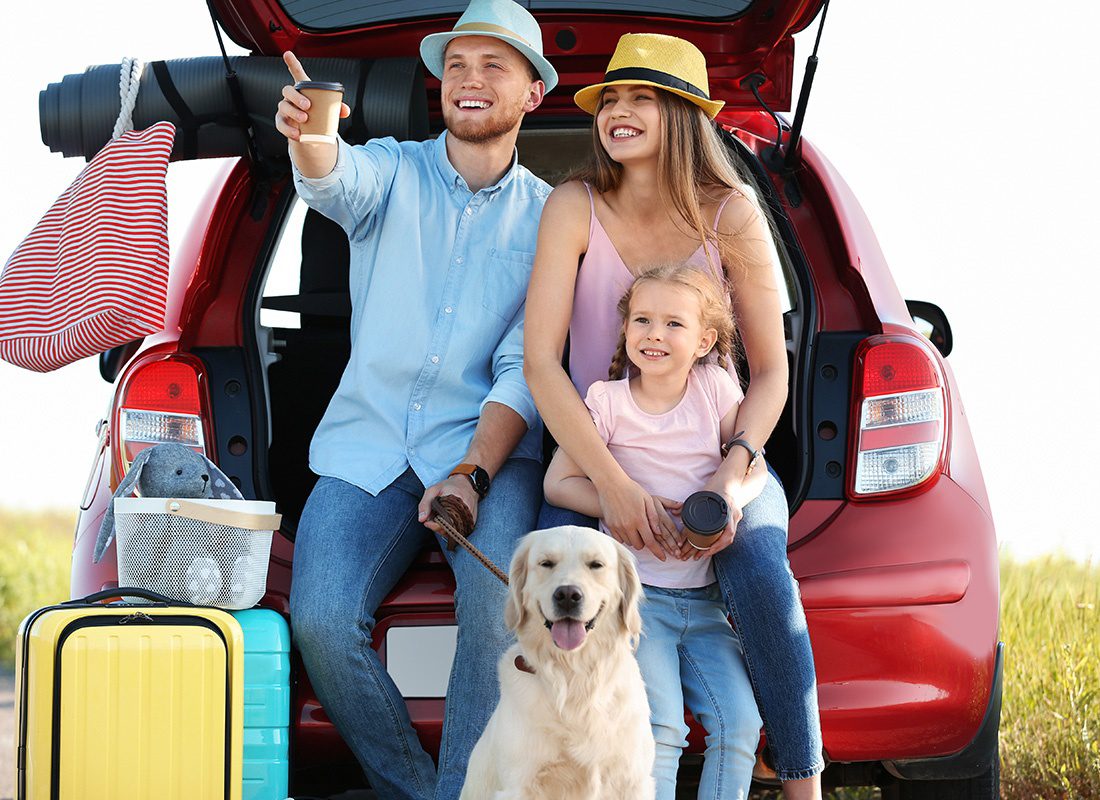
[0,122,176,372]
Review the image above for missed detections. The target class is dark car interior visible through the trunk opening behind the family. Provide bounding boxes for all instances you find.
[254,127,807,527]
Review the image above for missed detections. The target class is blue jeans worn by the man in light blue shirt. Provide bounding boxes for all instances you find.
[290,459,542,800]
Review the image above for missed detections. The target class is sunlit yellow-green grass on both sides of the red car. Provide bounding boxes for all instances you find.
[0,509,1100,800]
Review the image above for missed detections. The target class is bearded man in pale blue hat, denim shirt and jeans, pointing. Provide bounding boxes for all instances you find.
[276,0,558,800]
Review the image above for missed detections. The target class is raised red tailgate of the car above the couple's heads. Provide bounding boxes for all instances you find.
[212,0,824,116]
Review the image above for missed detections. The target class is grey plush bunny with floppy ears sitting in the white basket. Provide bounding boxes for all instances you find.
[92,443,244,563]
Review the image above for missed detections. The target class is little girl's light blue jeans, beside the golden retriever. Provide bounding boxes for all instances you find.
[638,583,760,800]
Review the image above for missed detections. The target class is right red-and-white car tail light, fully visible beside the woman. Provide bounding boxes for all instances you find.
[849,336,947,500]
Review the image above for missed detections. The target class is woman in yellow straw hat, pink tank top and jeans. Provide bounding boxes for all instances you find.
[525,34,823,798]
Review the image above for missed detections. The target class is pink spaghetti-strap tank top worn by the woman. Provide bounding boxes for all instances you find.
[569,184,737,397]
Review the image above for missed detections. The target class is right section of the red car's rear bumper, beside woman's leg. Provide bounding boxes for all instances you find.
[790,476,1001,761]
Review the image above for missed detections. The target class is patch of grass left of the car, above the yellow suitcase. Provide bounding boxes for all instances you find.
[0,509,76,669]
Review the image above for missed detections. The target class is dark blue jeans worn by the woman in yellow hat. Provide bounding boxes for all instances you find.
[539,472,825,780]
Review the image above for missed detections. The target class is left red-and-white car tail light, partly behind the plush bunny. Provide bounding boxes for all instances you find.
[112,354,209,479]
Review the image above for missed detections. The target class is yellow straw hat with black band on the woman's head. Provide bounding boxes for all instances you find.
[573,33,726,120]
